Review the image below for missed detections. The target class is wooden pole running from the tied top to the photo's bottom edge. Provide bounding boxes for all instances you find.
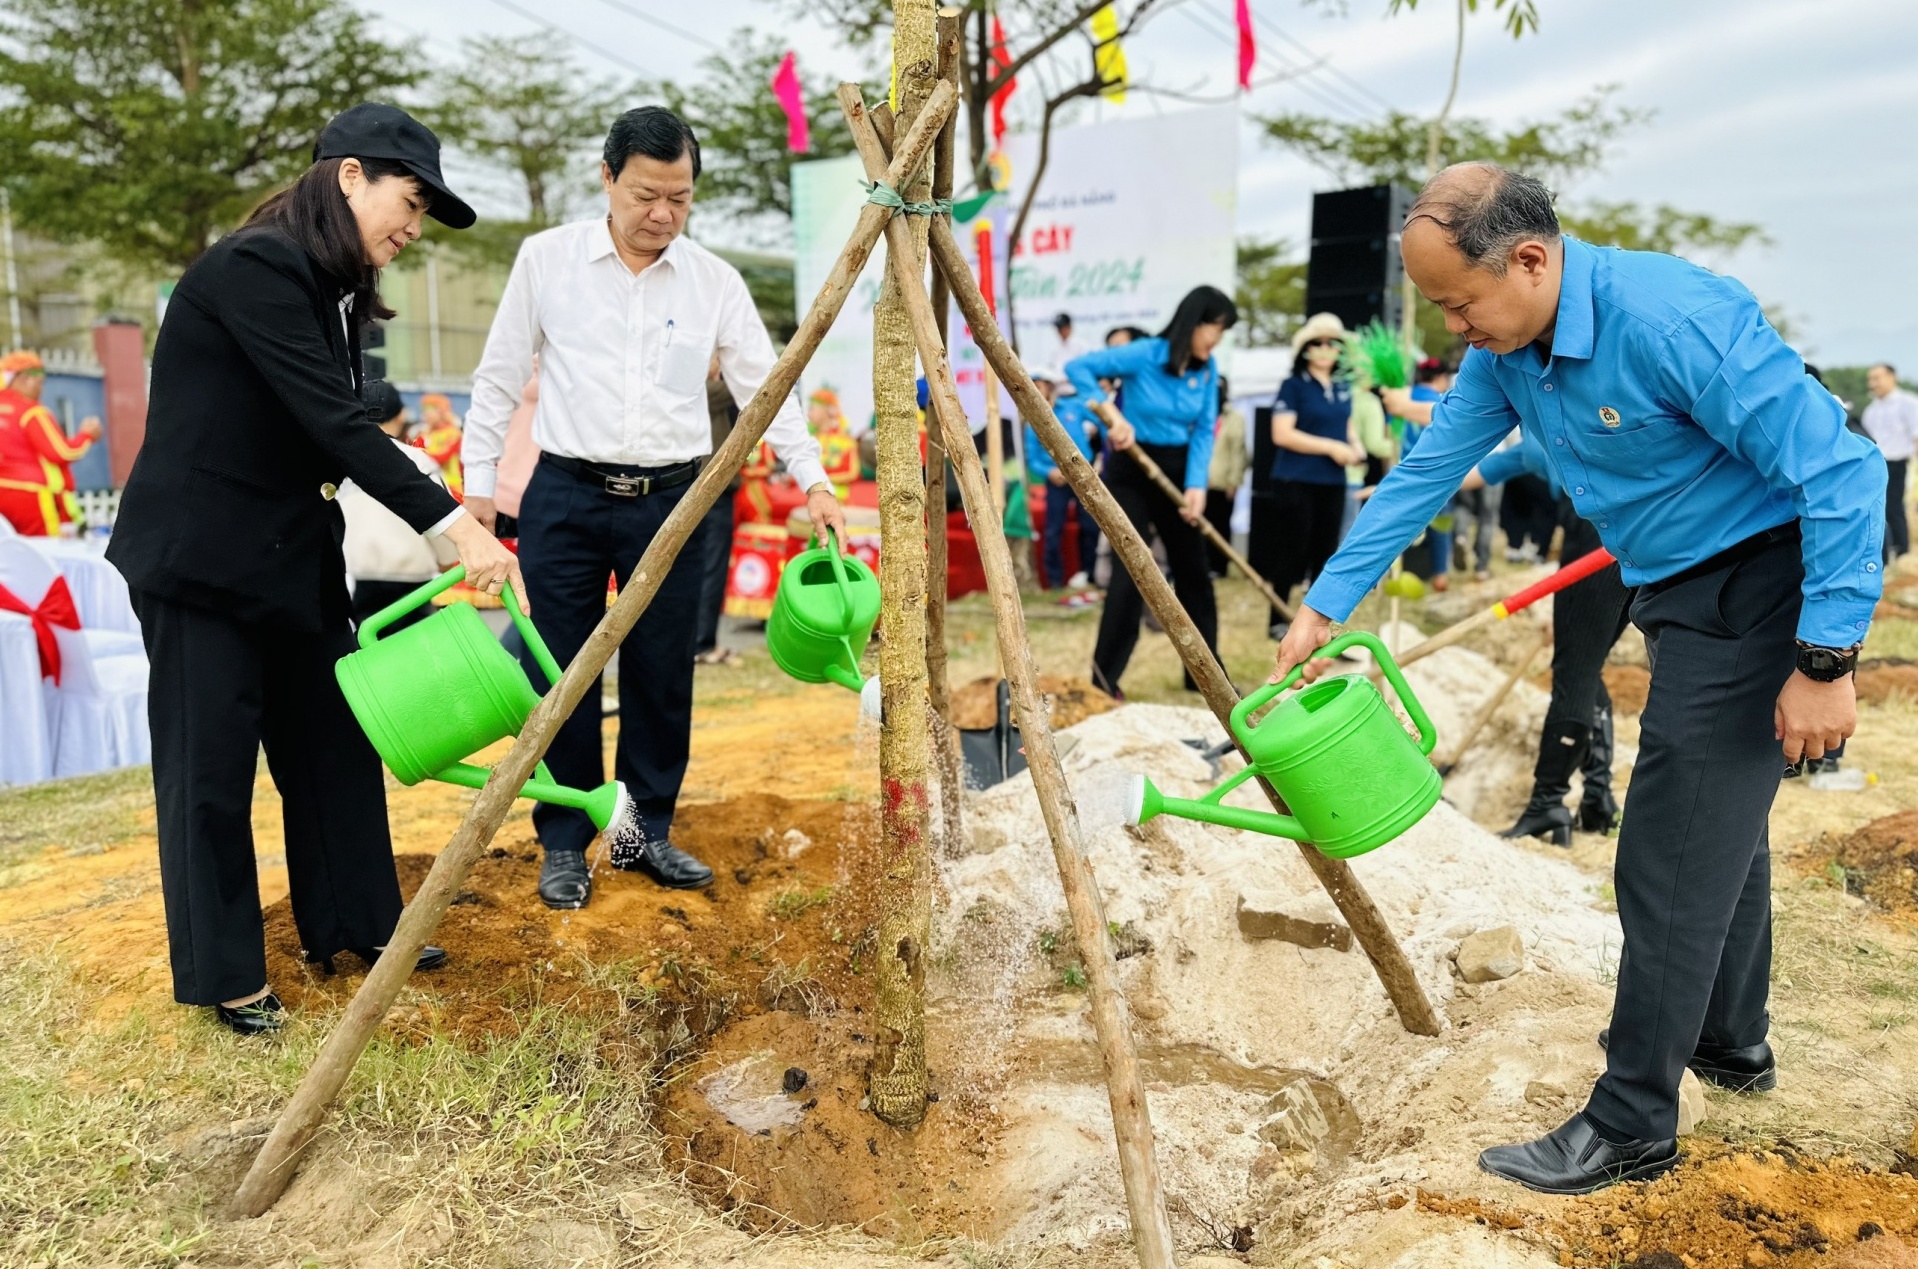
[838,84,1174,1269]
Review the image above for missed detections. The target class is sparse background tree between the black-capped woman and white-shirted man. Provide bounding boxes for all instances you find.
[420,33,635,263]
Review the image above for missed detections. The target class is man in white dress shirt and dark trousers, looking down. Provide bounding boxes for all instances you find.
[464,105,846,909]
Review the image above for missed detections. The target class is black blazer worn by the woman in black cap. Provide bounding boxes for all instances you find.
[107,228,456,631]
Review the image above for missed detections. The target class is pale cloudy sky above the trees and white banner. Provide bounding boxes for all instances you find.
[376,0,1918,368]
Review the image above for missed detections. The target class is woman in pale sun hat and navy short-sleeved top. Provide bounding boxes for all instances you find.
[1268,312,1366,638]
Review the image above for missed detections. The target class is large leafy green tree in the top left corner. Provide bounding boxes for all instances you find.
[0,0,418,272]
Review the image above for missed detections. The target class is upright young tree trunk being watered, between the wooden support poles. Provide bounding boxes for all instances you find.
[869,0,944,1129]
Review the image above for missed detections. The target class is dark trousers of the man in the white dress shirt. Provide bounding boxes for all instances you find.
[520,462,706,851]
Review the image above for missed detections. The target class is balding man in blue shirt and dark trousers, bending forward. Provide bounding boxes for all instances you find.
[1277,163,1885,1194]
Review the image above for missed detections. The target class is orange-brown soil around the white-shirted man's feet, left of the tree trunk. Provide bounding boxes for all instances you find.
[267,796,875,1035]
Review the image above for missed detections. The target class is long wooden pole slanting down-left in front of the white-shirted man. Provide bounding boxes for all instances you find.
[232,84,957,1217]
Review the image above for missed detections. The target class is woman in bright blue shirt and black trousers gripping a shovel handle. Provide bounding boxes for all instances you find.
[1066,286,1239,698]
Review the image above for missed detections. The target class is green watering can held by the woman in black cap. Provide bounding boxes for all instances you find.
[334,565,633,832]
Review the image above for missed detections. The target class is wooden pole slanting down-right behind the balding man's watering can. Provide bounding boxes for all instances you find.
[932,217,1440,1035]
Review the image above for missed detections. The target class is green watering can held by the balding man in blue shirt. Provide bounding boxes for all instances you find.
[1130,631,1442,859]
